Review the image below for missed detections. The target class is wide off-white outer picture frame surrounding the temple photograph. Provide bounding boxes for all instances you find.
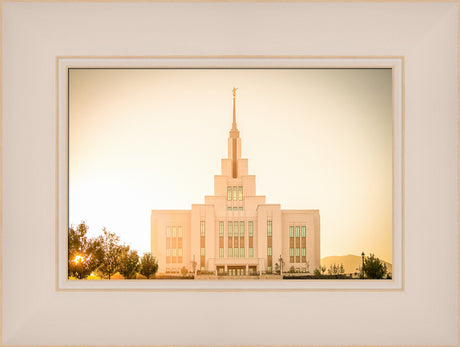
[2,2,458,345]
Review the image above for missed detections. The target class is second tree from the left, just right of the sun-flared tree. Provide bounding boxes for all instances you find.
[98,228,126,279]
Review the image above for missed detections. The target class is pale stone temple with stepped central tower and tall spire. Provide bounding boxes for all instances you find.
[151,88,320,276]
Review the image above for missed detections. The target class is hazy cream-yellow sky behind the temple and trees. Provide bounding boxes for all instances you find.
[69,69,392,262]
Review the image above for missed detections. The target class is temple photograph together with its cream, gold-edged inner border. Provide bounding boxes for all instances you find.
[58,57,403,290]
